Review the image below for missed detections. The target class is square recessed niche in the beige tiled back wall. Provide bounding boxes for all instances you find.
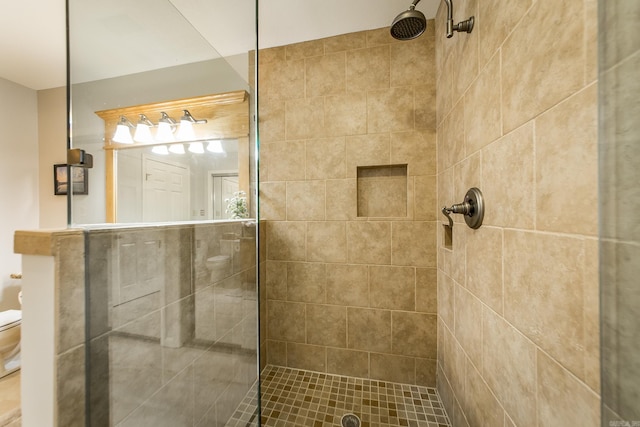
[358,165,407,218]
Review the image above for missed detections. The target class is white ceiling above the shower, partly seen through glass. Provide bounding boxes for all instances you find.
[0,0,440,90]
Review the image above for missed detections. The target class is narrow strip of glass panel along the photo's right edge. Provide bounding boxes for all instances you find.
[598,0,640,427]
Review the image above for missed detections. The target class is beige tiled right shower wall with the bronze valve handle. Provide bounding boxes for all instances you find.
[435,0,600,427]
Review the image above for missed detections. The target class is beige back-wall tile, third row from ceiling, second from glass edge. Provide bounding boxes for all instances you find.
[285,97,324,140]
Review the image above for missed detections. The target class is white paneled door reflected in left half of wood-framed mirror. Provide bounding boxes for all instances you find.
[142,158,190,222]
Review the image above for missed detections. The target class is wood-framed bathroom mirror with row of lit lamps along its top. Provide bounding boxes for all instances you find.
[96,91,250,223]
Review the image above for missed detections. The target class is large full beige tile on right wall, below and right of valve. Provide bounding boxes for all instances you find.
[504,231,584,377]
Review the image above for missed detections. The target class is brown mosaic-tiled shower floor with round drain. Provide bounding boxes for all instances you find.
[227,366,451,427]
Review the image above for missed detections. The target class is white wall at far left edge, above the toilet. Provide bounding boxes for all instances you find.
[0,79,39,310]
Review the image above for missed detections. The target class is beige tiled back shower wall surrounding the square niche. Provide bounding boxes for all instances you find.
[259,22,437,386]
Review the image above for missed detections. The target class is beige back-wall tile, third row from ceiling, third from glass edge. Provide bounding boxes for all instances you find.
[324,92,367,136]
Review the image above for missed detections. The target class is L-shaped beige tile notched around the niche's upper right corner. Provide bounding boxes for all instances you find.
[391,130,436,176]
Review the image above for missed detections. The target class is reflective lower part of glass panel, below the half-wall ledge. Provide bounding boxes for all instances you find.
[85,221,258,427]
